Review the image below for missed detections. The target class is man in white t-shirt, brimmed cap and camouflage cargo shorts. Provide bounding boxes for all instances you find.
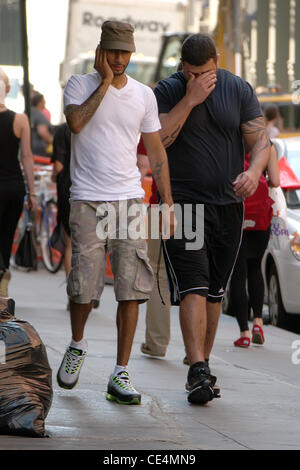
[57,21,175,404]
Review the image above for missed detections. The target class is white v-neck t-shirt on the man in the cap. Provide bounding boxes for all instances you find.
[64,72,161,201]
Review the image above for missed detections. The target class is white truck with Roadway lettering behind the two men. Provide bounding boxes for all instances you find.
[60,0,188,87]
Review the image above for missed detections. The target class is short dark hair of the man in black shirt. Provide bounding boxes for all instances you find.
[181,33,217,66]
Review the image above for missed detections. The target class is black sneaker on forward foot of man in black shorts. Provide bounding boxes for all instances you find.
[187,362,215,405]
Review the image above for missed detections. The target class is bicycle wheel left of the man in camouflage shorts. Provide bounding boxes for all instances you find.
[40,201,64,274]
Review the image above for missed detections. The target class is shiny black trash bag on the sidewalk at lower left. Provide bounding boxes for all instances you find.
[0,297,53,437]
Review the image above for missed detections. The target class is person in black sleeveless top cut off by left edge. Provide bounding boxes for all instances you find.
[0,68,36,297]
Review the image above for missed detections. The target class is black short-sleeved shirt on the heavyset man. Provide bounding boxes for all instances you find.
[154,69,263,205]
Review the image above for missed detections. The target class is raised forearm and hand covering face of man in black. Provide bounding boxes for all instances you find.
[159,70,217,148]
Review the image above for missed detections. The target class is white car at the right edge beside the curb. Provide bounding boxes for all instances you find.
[262,137,300,326]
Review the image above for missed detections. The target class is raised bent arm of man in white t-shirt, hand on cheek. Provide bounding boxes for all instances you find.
[65,46,114,134]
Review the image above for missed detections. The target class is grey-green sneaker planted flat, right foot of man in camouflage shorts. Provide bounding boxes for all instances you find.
[106,370,141,405]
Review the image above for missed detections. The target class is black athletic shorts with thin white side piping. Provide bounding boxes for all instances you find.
[163,202,244,305]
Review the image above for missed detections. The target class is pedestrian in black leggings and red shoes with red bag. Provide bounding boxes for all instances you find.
[228,146,280,348]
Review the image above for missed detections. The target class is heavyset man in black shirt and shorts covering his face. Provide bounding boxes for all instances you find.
[155,34,270,404]
